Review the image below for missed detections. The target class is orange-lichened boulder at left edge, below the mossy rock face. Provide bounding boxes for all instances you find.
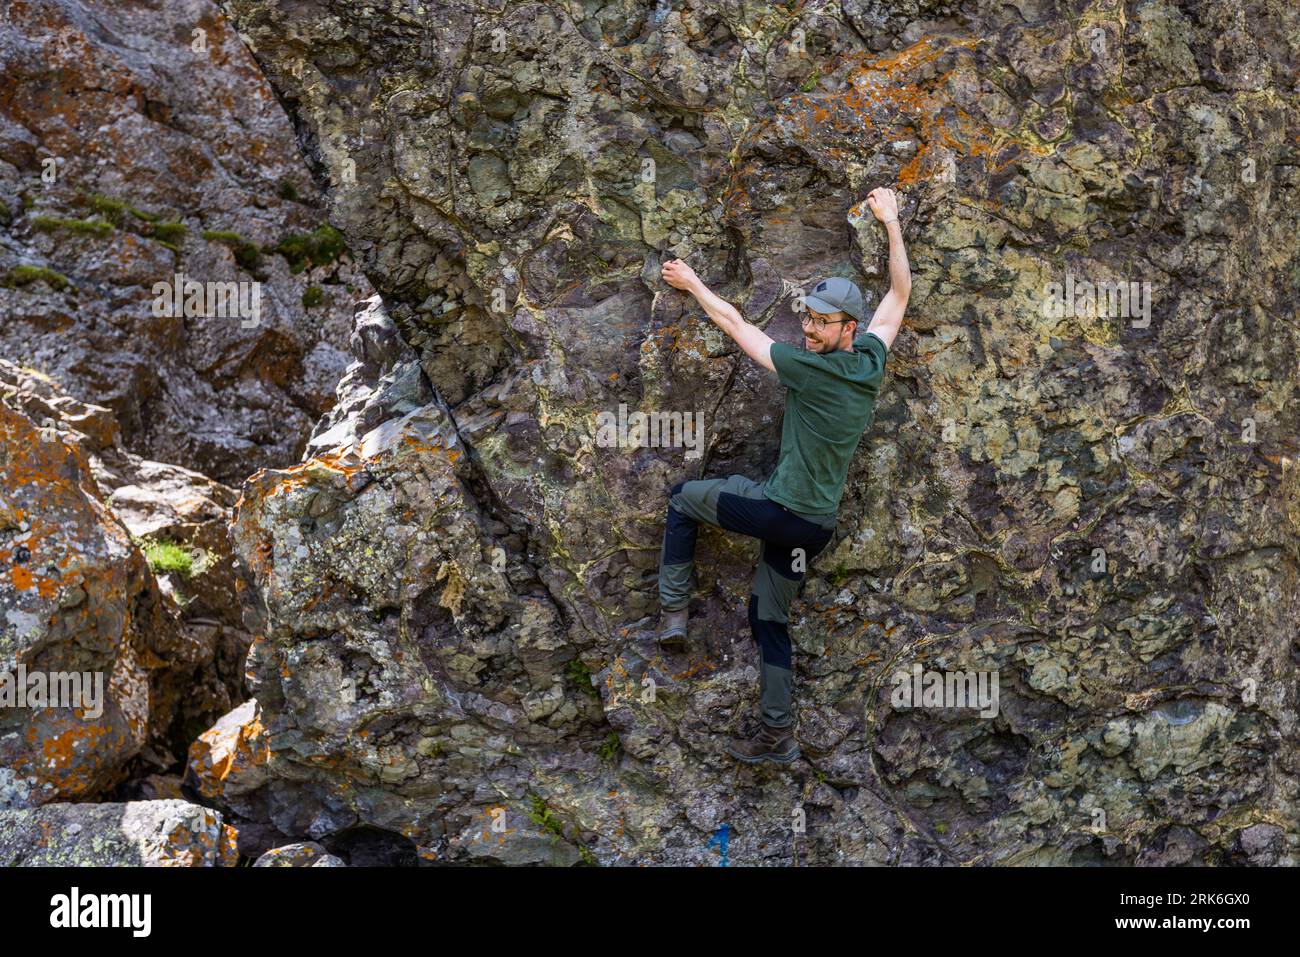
[0,360,248,807]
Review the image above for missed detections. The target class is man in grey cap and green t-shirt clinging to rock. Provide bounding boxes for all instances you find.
[659,187,911,763]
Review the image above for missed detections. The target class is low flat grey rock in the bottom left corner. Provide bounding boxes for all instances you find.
[0,801,239,867]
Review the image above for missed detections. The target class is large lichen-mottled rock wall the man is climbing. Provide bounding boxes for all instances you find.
[208,0,1300,865]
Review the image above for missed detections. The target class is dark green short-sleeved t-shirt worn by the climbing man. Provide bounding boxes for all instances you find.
[763,332,888,515]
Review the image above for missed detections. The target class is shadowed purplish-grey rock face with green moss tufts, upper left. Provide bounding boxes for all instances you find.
[0,0,369,484]
